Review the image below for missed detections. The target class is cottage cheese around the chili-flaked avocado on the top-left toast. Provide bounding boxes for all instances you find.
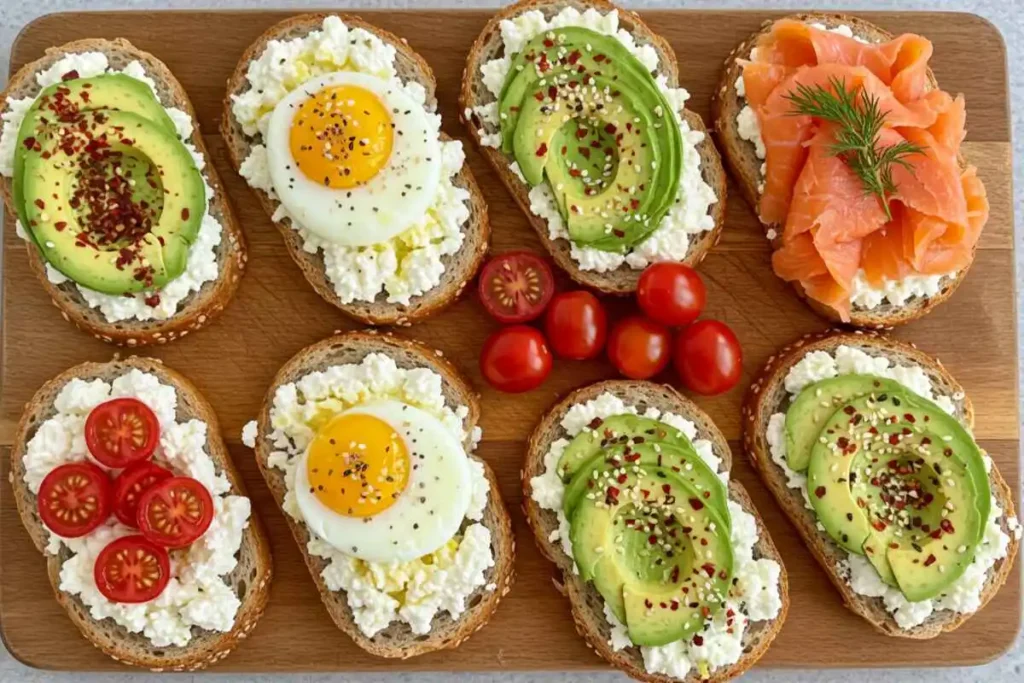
[0,52,223,323]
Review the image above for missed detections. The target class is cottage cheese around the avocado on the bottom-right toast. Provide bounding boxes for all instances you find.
[766,345,1019,629]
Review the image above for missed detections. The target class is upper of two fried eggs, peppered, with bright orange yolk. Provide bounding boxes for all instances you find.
[265,72,441,247]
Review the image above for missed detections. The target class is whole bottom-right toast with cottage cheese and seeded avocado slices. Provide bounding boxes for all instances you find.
[742,332,1021,639]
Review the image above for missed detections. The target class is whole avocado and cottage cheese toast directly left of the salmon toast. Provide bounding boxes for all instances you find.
[460,0,726,294]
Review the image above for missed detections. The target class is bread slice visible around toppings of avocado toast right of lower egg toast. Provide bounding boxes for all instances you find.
[522,380,790,683]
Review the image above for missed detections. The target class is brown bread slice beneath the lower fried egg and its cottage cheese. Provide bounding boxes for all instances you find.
[249,331,515,659]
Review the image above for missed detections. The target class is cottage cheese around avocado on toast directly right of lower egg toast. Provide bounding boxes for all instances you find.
[529,392,782,680]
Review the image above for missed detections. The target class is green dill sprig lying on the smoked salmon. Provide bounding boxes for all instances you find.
[785,76,924,220]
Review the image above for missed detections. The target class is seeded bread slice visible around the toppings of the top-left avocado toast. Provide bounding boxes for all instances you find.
[0,38,247,347]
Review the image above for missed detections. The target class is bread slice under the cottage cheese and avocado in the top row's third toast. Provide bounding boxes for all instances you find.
[459,0,726,294]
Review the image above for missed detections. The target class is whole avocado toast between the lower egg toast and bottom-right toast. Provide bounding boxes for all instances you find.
[522,380,790,683]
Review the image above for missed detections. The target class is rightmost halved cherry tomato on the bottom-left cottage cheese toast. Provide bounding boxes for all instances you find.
[138,477,213,548]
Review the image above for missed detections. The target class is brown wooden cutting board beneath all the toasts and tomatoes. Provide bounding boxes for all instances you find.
[0,11,1021,672]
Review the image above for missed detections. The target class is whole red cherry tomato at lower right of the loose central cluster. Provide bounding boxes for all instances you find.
[673,321,743,396]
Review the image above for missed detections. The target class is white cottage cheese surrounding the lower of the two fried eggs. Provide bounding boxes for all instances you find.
[253,353,496,638]
